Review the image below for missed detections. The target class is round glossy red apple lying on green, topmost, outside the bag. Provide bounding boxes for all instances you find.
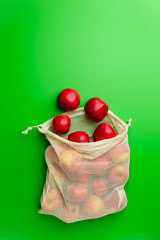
[57,88,80,111]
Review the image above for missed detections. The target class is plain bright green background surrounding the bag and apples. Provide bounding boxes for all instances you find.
[0,0,160,240]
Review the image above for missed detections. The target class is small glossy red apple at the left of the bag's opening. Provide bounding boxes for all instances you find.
[52,115,71,134]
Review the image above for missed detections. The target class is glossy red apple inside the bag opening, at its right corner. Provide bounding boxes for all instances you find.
[93,123,116,142]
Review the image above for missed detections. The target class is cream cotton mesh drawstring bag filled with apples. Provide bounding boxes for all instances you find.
[23,108,131,223]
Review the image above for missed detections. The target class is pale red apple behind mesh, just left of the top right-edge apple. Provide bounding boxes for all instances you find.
[88,154,111,174]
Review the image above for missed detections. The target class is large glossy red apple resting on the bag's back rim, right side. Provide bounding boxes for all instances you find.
[84,97,108,122]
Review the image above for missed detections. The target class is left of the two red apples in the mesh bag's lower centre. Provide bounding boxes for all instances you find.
[67,183,87,204]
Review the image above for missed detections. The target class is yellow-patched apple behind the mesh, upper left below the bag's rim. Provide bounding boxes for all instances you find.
[59,150,82,172]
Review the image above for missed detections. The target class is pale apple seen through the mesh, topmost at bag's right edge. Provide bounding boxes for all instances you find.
[108,144,129,163]
